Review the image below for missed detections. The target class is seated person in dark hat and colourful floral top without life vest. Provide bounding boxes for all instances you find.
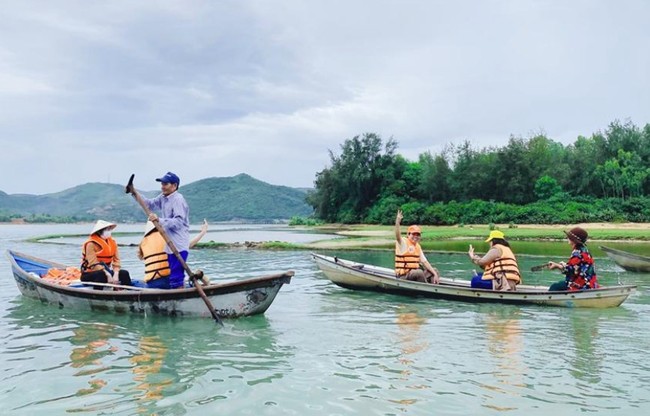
[548,227,598,291]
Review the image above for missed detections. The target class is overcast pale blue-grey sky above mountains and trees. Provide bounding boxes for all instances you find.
[0,0,650,194]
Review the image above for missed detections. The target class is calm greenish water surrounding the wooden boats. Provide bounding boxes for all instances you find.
[0,225,650,416]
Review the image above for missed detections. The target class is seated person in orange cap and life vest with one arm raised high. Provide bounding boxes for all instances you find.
[395,210,440,283]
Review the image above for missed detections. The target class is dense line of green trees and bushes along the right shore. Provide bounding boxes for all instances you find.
[307,121,650,225]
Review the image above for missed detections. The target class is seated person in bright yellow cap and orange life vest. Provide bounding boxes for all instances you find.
[468,230,521,291]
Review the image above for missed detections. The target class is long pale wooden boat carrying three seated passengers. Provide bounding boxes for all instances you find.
[312,253,636,308]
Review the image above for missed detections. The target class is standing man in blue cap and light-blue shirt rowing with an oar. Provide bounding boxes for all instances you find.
[134,172,190,289]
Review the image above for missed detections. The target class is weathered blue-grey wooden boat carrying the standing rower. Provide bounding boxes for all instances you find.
[7,250,294,318]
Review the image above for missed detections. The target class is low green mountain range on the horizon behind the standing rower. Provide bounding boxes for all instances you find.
[0,173,312,223]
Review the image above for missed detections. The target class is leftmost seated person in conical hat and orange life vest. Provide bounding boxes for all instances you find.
[80,220,131,286]
